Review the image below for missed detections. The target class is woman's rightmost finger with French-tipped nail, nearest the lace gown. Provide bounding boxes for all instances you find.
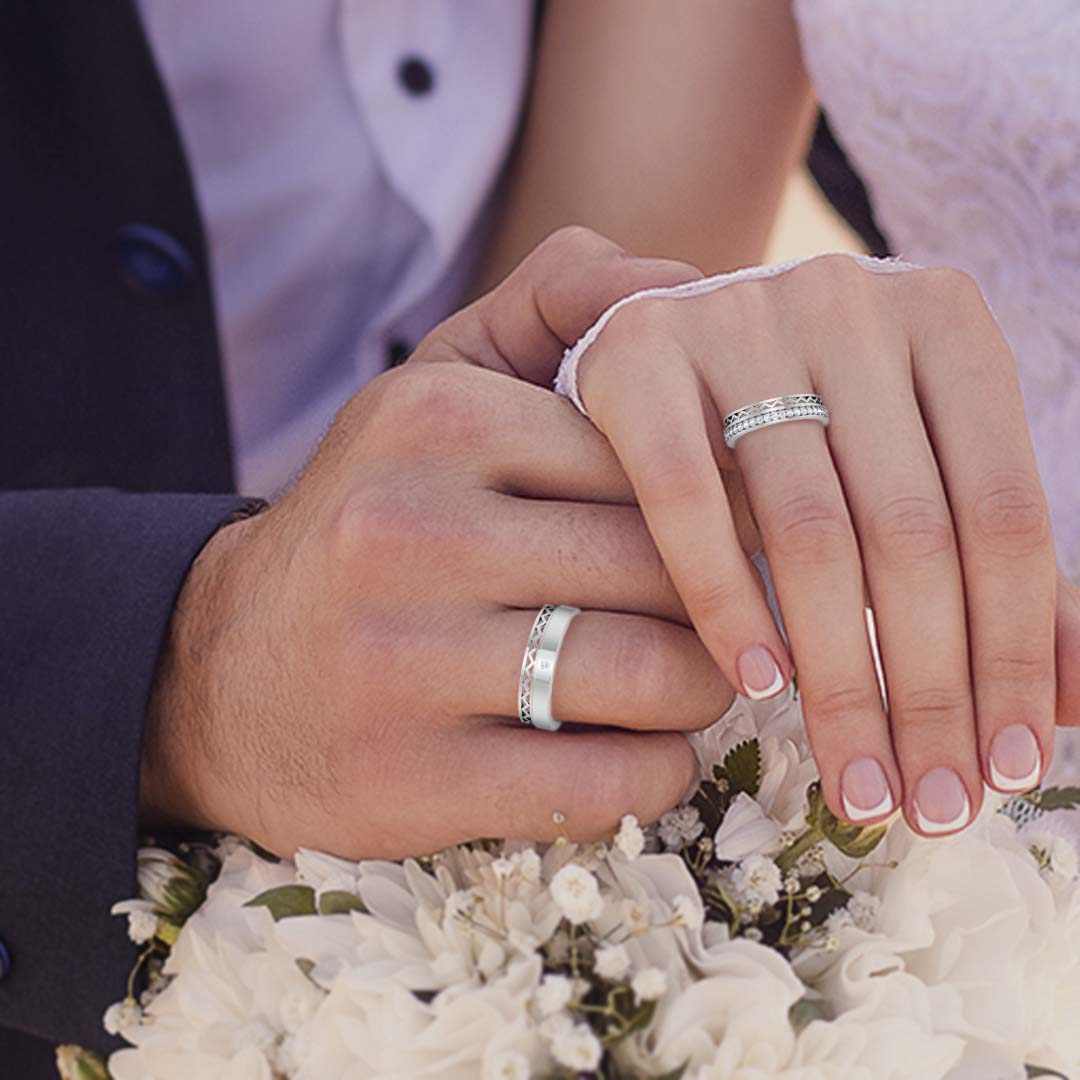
[905,271,1057,792]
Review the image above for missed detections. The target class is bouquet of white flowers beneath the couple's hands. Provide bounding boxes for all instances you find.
[57,688,1080,1080]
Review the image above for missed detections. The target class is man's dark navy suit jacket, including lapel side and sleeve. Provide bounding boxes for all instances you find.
[0,0,885,1080]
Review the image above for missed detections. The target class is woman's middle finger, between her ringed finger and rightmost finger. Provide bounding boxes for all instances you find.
[810,308,983,835]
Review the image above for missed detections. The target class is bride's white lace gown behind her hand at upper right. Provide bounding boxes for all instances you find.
[794,0,1080,799]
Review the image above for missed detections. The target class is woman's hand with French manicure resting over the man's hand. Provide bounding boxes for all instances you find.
[544,230,1080,834]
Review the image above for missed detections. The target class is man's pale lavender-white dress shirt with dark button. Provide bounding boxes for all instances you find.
[139,0,532,495]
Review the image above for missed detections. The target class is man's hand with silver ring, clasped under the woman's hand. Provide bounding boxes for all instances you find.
[143,231,733,858]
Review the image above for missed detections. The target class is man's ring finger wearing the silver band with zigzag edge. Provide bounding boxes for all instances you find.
[460,610,734,731]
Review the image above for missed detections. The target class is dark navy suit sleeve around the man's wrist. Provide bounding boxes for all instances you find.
[0,489,251,1054]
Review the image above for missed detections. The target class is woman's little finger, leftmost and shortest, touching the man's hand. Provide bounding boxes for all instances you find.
[581,315,793,699]
